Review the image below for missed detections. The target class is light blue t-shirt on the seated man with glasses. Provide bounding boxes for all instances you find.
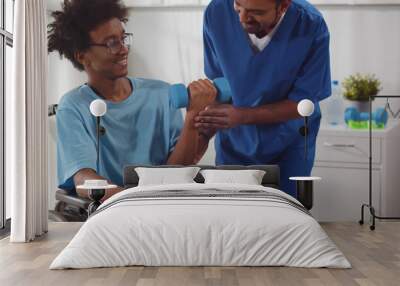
[57,78,183,190]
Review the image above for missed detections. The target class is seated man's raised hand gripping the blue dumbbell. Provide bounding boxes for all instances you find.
[188,79,217,115]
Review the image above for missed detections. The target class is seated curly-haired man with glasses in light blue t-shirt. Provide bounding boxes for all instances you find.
[48,0,216,200]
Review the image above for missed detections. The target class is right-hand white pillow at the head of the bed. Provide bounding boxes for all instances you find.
[200,170,265,185]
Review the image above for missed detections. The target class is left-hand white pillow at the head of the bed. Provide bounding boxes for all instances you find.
[135,167,200,186]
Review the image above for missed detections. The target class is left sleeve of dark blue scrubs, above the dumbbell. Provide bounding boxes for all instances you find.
[203,10,223,80]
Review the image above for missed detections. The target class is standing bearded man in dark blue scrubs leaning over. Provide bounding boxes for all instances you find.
[195,0,331,196]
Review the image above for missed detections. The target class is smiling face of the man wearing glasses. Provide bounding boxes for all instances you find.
[76,18,129,80]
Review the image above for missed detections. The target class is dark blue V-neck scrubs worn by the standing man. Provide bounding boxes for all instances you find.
[203,0,331,197]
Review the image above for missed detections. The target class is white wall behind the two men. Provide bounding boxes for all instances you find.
[49,0,400,206]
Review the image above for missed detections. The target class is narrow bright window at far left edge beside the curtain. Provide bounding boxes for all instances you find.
[0,0,14,232]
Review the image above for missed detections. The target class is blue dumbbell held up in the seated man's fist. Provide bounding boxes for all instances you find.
[169,77,232,108]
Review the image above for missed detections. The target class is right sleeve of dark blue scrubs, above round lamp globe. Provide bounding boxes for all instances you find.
[289,19,331,102]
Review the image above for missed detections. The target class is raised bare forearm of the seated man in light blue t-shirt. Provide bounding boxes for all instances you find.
[167,112,208,165]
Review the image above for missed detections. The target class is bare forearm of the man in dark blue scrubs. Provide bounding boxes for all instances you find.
[239,99,300,124]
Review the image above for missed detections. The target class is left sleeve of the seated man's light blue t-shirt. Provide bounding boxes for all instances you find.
[57,107,97,190]
